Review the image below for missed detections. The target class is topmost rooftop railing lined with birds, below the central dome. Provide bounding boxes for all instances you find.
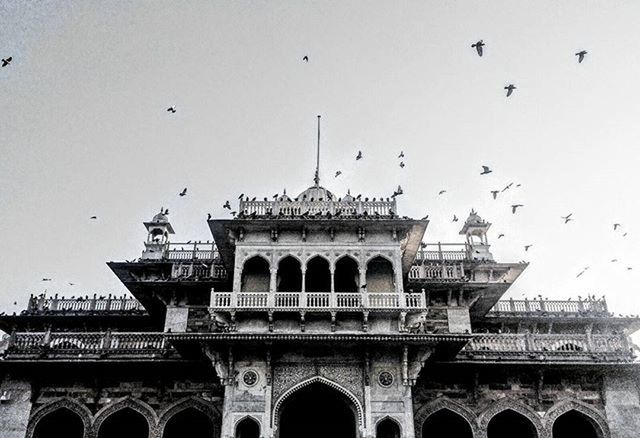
[239,199,397,217]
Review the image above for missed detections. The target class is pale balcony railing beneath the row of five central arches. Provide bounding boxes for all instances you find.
[210,292,425,311]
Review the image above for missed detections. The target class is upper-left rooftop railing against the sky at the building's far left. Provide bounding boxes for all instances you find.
[25,294,145,314]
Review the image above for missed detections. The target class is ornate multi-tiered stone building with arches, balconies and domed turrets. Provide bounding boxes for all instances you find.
[0,178,640,438]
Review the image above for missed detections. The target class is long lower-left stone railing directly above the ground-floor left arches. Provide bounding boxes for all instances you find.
[2,332,175,359]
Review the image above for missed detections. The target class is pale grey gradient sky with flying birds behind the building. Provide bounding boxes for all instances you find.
[0,0,640,326]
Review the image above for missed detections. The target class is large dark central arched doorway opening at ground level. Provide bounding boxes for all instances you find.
[277,382,357,438]
